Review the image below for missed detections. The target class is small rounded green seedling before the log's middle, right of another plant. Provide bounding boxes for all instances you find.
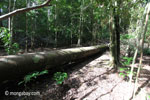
[53,72,68,84]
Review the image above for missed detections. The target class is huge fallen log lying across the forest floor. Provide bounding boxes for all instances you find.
[0,45,108,83]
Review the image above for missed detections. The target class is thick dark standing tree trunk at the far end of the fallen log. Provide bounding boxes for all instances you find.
[110,1,121,71]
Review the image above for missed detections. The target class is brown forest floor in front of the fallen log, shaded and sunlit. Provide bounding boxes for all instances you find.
[0,52,150,100]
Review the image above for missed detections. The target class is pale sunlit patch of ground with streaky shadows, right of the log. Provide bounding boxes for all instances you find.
[62,53,148,100]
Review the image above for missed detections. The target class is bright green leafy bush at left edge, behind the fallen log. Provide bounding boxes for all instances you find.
[0,27,19,54]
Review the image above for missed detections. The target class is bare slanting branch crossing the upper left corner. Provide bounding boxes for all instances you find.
[0,0,51,20]
